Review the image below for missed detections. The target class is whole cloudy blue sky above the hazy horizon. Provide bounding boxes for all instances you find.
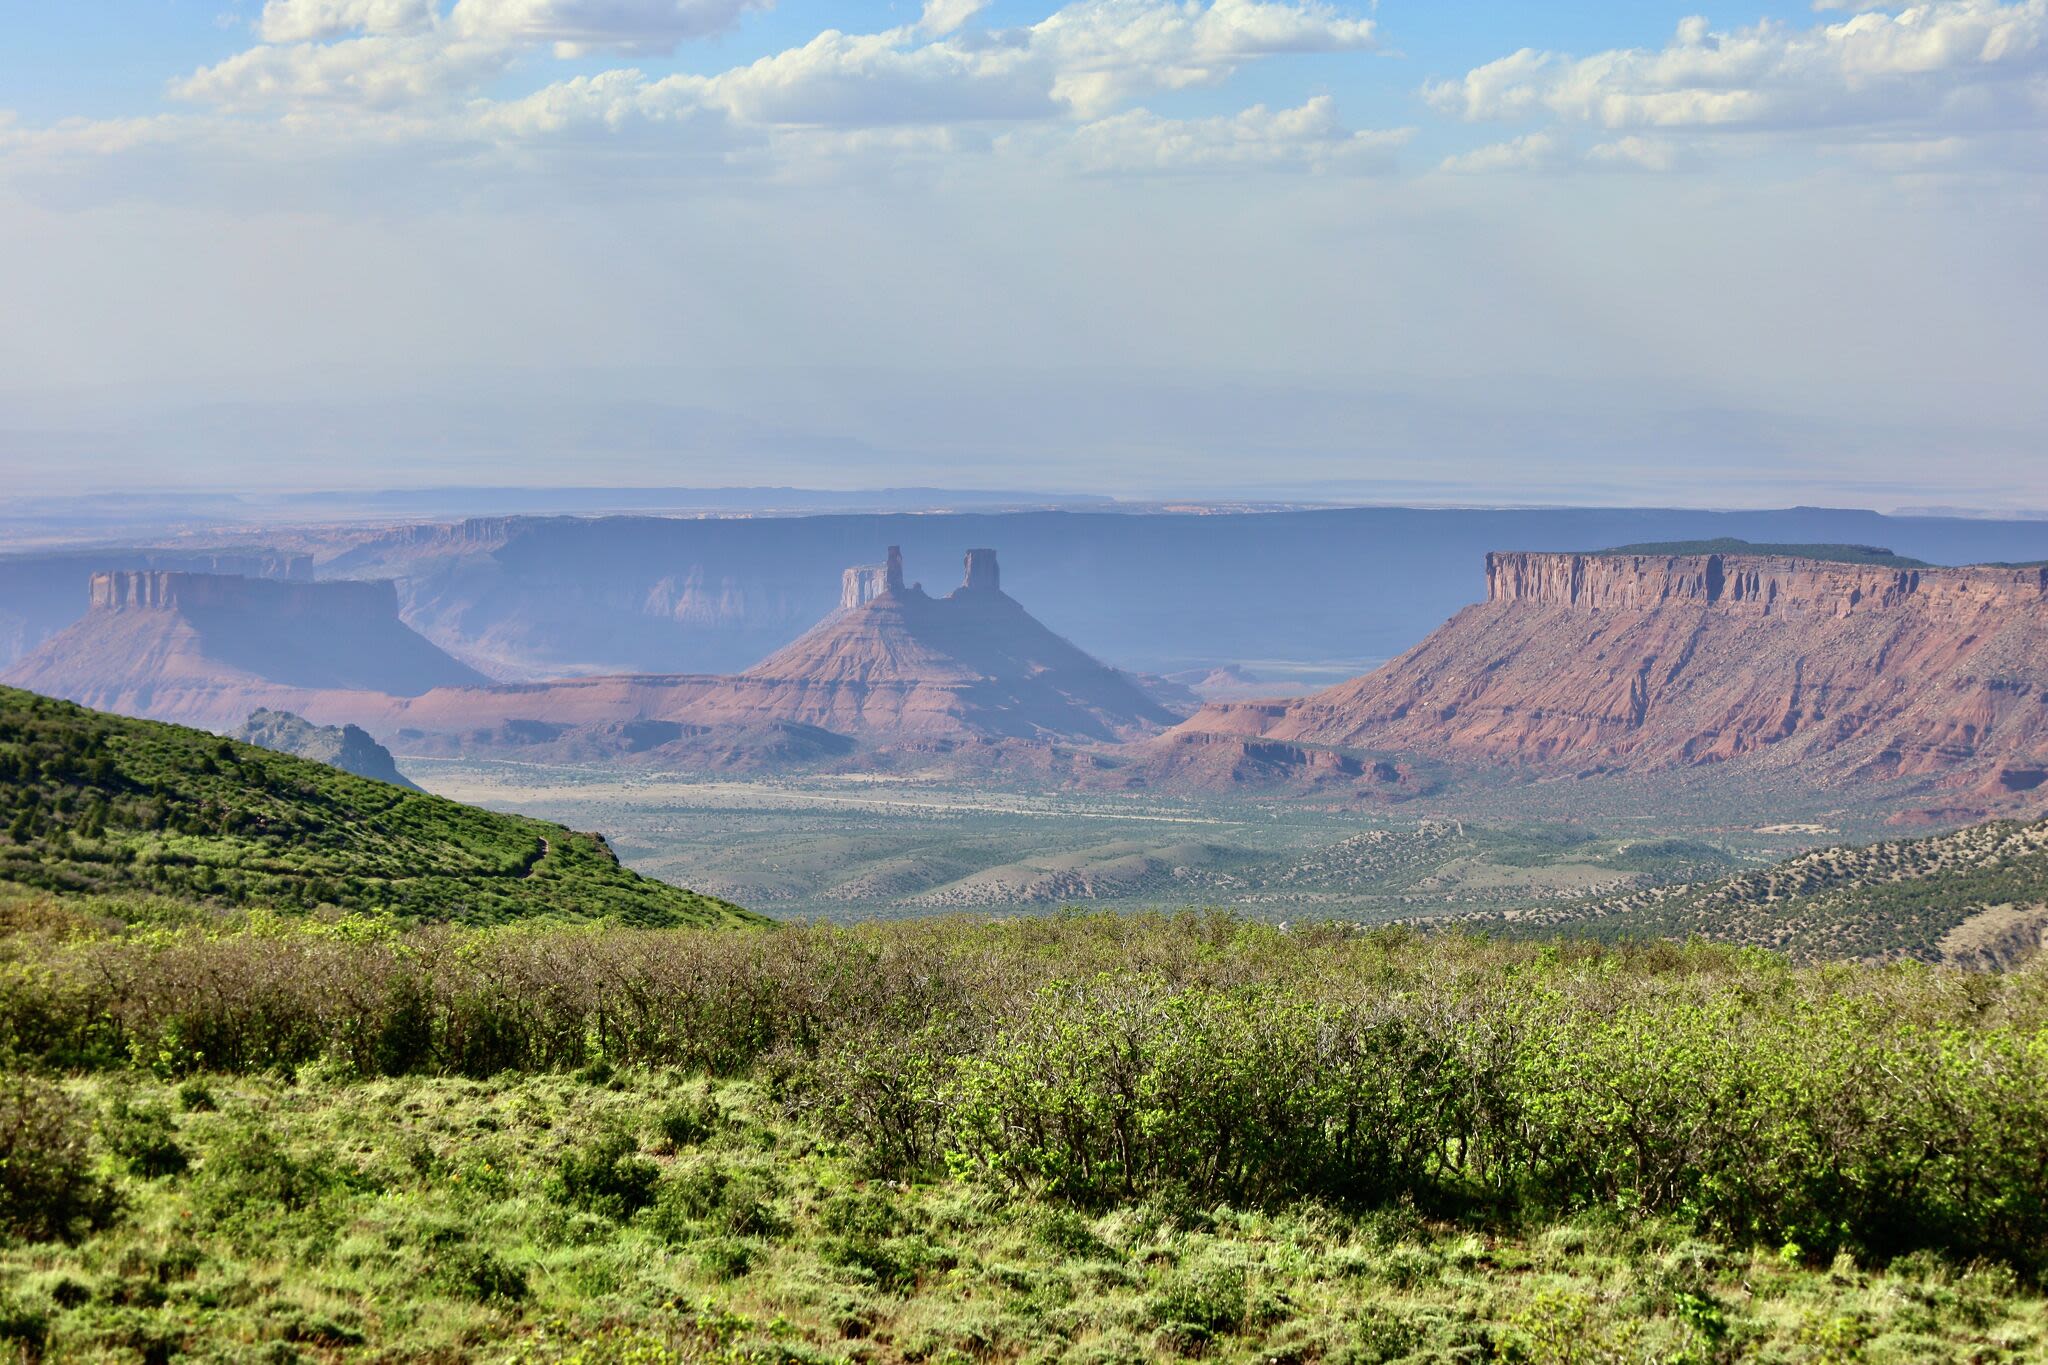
[0,0,2048,510]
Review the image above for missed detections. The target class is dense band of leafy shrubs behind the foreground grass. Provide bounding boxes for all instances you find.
[0,915,2048,1279]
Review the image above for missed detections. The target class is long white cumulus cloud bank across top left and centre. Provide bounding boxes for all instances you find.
[8,0,1407,196]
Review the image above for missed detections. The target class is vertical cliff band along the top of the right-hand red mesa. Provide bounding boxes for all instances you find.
[1487,553,2048,616]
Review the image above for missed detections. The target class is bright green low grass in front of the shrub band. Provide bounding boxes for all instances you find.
[0,1064,2048,1365]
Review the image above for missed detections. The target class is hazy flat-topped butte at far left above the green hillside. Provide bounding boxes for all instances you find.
[0,571,485,729]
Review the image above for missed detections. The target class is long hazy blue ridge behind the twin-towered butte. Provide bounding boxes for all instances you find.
[303,508,2048,677]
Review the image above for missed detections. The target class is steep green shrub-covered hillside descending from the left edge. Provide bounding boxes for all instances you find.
[0,688,754,925]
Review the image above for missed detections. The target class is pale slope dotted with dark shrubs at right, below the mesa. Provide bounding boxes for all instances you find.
[1487,821,2048,960]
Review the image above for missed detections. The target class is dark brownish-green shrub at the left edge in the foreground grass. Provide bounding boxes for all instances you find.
[0,1074,117,1242]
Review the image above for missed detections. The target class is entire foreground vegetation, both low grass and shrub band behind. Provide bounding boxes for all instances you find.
[0,892,2048,1363]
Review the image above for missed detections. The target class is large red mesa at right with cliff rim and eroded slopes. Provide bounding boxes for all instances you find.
[1176,555,2048,796]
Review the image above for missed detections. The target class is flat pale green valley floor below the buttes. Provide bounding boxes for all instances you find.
[403,757,1880,921]
